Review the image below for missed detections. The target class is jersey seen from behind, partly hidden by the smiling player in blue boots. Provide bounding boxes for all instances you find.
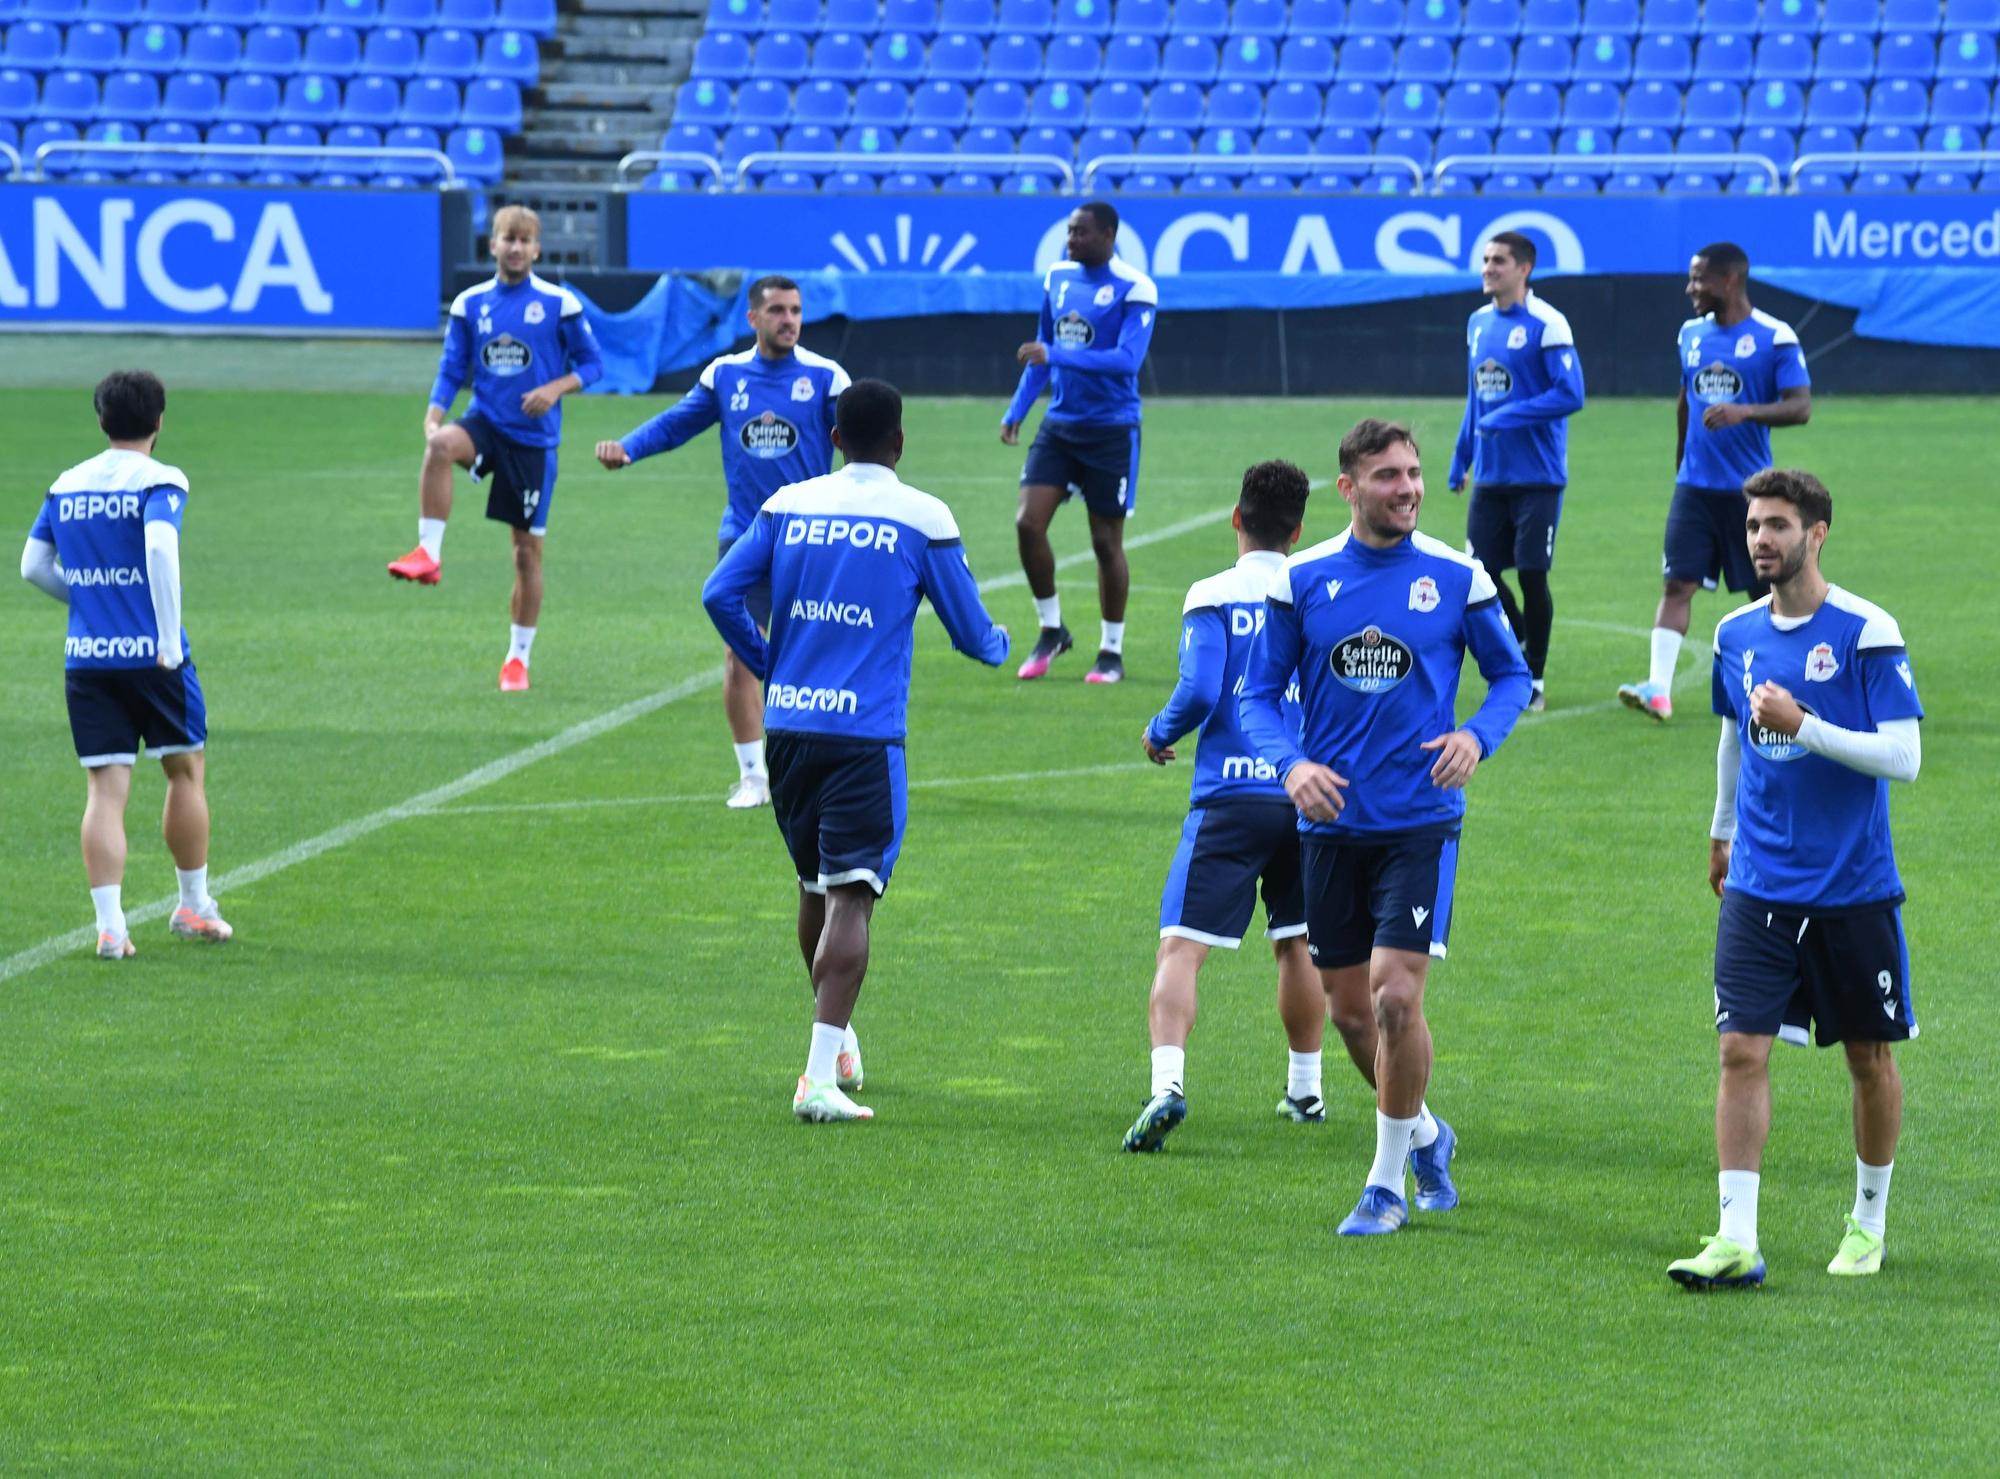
[1146,550,1298,805]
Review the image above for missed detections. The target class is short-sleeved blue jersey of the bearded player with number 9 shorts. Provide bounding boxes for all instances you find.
[1714,586,1924,911]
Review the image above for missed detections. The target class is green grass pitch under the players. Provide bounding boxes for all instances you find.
[0,363,2000,1475]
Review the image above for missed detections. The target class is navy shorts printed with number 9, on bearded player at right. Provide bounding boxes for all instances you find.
[1716,891,1916,1047]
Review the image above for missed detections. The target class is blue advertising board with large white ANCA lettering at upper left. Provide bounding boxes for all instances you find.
[0,184,442,334]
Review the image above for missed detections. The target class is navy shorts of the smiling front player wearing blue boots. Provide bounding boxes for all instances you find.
[1300,833,1458,971]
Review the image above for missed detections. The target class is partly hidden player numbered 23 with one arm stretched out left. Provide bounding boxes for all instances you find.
[598,278,848,811]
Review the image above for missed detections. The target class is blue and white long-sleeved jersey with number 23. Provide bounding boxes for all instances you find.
[620,348,852,540]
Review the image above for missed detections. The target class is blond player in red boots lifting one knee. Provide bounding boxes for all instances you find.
[388,206,604,694]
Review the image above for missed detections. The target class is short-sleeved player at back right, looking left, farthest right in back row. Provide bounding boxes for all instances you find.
[1618,242,1812,722]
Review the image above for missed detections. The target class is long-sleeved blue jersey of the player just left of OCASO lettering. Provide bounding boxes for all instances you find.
[1006,258,1160,426]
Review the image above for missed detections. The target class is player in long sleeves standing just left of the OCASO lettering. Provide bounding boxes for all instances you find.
[1000,200,1160,684]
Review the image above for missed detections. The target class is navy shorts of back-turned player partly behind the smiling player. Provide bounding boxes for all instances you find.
[1160,799,1306,949]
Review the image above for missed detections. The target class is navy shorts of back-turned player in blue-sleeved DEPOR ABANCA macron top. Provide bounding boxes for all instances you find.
[764,730,910,893]
